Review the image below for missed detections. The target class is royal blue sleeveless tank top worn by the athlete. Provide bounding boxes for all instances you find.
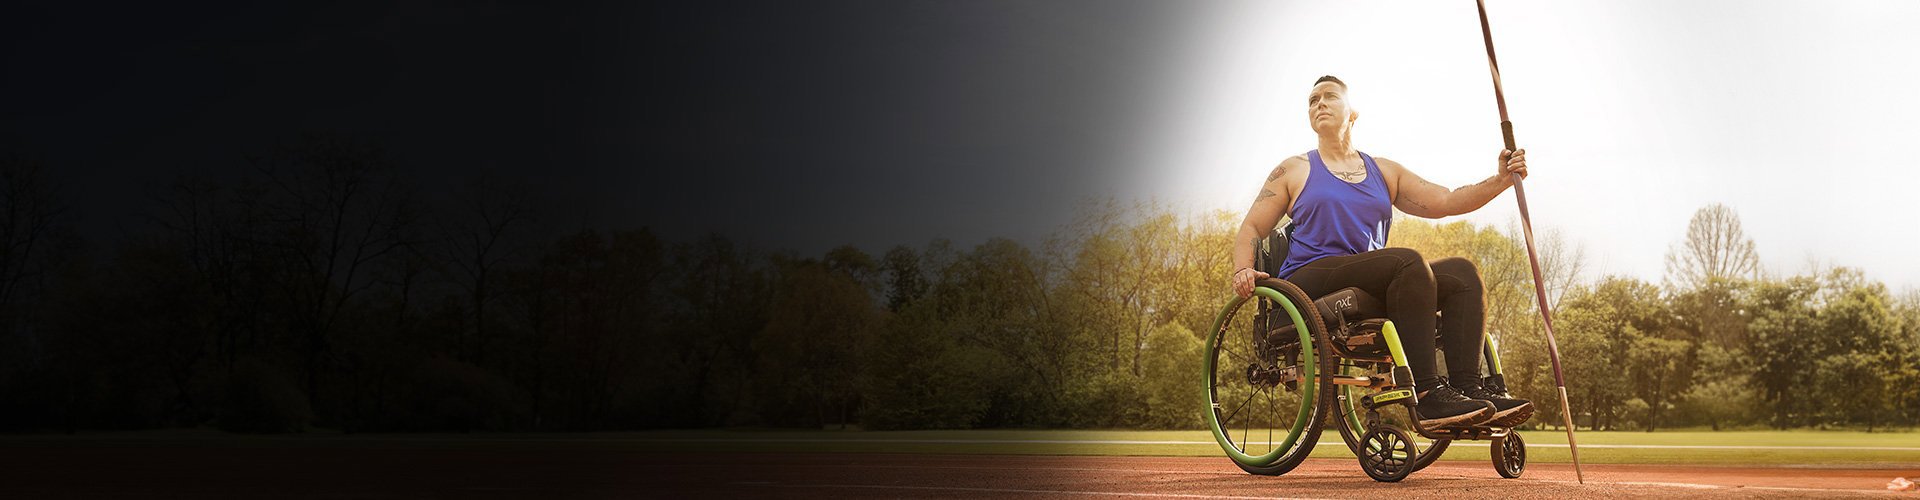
[1281,150,1394,277]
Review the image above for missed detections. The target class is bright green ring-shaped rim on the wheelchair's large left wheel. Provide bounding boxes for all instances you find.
[1202,287,1319,467]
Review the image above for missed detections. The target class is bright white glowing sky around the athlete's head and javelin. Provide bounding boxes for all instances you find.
[1142,0,1920,290]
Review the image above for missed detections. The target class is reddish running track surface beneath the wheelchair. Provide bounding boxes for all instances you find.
[0,446,1920,500]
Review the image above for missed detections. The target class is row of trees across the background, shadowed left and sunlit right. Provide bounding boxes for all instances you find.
[0,137,1920,433]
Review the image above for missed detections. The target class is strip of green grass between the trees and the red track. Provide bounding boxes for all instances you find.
[15,429,1920,469]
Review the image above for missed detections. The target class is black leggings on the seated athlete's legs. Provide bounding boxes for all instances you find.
[1286,248,1486,387]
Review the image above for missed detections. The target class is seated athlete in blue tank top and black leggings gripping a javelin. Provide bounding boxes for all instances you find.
[1233,77,1534,427]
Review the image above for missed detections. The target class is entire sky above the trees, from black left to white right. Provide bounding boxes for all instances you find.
[18,0,1920,288]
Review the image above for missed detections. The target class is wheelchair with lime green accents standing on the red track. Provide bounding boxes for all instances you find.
[1206,231,1526,483]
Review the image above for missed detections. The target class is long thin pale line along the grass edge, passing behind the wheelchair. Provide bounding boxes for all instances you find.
[632,438,1920,452]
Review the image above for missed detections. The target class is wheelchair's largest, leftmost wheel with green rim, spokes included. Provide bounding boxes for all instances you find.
[1204,279,1336,475]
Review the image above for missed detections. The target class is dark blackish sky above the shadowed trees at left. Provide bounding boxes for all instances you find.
[0,2,1192,254]
